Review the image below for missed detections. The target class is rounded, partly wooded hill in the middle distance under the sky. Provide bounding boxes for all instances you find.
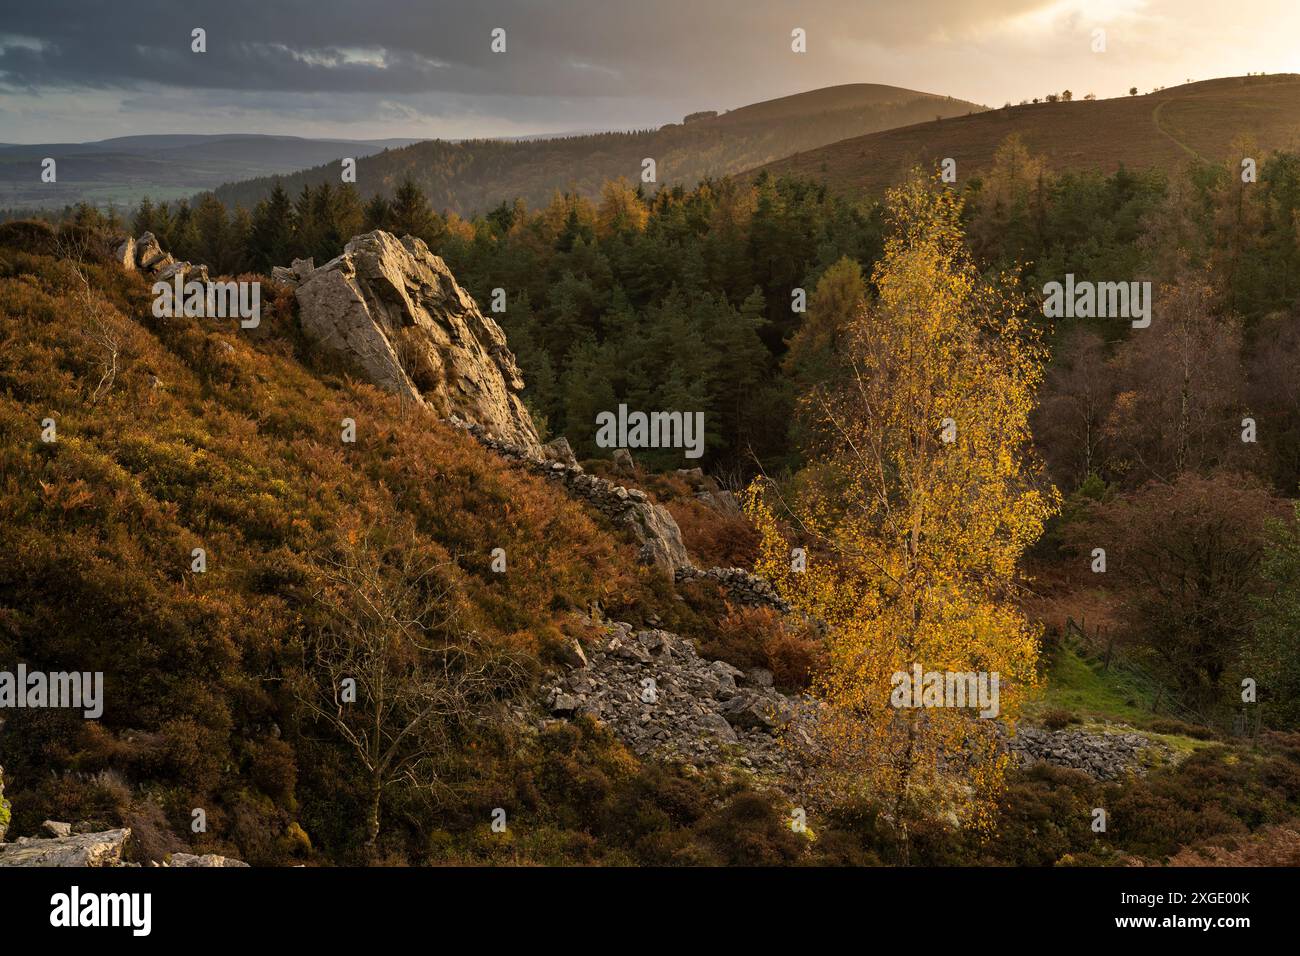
[217,83,985,213]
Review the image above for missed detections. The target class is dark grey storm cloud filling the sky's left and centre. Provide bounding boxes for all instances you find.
[0,0,1043,98]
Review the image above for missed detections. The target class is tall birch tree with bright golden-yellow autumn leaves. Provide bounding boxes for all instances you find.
[748,176,1057,852]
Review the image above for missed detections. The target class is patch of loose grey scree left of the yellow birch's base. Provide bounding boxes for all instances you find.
[543,623,816,784]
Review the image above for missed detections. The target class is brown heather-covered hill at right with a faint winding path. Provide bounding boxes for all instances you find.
[748,73,1300,193]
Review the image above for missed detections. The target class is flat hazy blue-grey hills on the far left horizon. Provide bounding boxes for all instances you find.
[0,134,416,208]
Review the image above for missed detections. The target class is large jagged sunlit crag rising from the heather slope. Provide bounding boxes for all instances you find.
[284,230,540,454]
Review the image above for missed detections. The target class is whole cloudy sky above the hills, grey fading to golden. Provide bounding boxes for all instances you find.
[0,0,1300,143]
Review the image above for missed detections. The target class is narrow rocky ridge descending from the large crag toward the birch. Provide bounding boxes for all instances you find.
[452,419,690,572]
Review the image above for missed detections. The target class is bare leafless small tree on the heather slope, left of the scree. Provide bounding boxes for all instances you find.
[299,528,527,847]
